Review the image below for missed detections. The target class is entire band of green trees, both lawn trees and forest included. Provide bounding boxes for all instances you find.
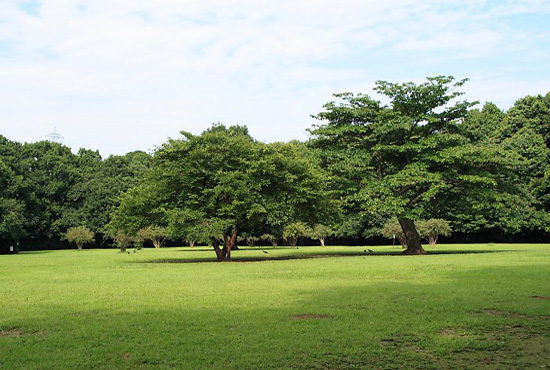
[0,76,550,261]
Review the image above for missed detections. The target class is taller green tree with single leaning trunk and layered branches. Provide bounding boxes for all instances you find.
[311,76,513,254]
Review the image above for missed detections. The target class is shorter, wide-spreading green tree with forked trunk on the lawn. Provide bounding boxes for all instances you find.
[112,124,331,261]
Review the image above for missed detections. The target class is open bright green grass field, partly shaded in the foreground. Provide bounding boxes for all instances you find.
[0,244,550,369]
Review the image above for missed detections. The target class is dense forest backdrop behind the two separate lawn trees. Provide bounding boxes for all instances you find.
[0,81,550,252]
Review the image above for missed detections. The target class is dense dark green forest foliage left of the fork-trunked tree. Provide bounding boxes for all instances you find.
[0,136,151,251]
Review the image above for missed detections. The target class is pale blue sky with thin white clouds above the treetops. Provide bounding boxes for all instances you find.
[0,0,550,157]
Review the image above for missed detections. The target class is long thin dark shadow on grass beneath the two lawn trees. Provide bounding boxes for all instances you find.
[141,250,511,263]
